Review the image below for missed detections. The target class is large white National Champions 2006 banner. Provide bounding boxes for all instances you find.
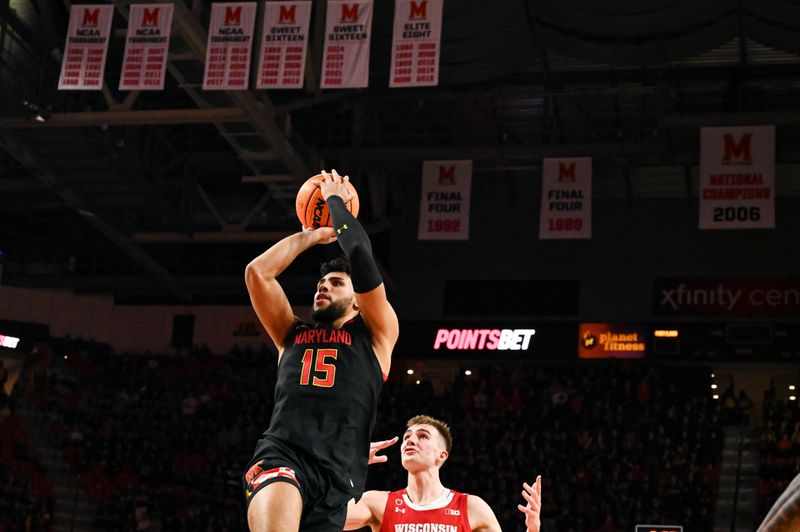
[699,126,775,229]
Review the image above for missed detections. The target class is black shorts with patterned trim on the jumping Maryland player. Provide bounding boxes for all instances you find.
[242,438,353,532]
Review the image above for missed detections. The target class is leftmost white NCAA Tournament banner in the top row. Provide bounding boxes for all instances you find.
[58,4,114,90]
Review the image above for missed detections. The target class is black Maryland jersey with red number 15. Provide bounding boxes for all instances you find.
[264,315,383,498]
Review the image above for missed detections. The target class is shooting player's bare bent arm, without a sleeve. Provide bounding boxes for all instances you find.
[244,227,336,354]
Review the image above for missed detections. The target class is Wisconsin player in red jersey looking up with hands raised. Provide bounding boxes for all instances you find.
[344,416,542,532]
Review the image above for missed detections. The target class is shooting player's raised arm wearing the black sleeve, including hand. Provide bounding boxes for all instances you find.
[319,170,400,373]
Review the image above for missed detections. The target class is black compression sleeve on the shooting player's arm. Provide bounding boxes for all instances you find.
[328,196,383,294]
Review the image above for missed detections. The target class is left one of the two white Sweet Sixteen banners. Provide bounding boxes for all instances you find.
[256,0,311,89]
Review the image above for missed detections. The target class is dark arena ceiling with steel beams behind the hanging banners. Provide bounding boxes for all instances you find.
[0,0,800,301]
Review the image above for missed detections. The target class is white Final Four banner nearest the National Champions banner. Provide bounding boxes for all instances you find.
[539,157,592,239]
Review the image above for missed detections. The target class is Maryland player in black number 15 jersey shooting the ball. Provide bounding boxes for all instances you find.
[243,170,399,532]
